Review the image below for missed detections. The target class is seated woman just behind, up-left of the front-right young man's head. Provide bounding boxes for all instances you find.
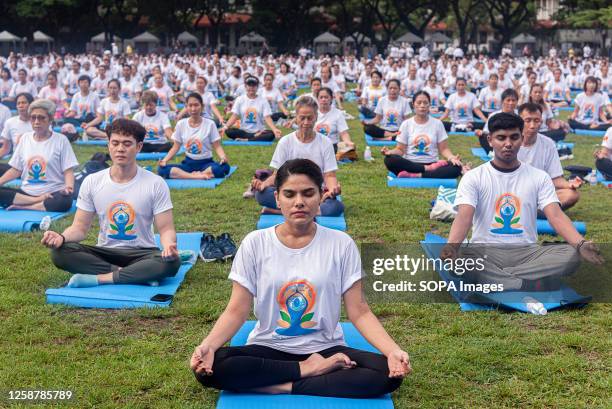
[440,78,487,132]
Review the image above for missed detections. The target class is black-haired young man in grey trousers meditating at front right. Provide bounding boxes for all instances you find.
[440,113,603,302]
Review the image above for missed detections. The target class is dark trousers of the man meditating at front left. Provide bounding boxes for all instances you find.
[51,243,181,284]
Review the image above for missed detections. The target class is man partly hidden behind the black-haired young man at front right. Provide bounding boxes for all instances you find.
[518,103,582,215]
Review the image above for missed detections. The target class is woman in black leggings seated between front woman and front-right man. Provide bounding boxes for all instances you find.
[381,91,467,179]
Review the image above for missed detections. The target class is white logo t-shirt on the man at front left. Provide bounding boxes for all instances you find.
[77,167,172,248]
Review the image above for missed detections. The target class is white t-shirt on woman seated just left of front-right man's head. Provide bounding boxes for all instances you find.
[396,117,448,163]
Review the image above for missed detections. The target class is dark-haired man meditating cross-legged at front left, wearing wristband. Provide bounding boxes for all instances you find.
[42,118,181,287]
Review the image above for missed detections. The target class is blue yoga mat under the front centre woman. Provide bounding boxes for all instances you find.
[217,321,393,409]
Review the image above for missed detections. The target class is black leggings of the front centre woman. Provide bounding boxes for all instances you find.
[194,345,402,398]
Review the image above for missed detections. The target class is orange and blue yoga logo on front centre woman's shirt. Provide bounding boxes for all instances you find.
[275,280,317,336]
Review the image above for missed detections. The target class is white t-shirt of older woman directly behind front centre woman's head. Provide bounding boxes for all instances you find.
[270,132,338,173]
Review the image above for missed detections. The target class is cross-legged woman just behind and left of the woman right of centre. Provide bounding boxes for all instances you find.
[361,79,412,141]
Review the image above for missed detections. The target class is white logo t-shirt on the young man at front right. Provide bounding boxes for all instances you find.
[455,162,559,244]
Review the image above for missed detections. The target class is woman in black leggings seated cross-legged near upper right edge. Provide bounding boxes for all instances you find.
[568,76,610,131]
